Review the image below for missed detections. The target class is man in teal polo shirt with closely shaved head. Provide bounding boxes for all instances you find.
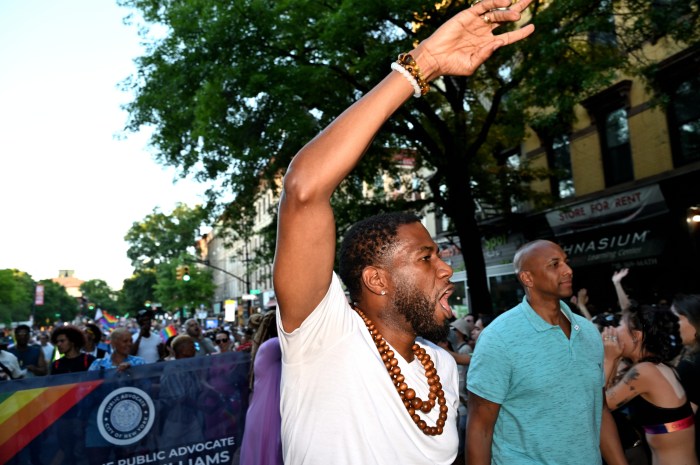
[467,240,626,465]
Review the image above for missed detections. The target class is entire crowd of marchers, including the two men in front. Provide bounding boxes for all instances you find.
[0,0,700,465]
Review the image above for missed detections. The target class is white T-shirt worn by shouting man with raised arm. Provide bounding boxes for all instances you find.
[278,273,458,465]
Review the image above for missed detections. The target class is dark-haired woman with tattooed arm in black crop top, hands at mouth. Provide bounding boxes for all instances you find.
[603,305,698,465]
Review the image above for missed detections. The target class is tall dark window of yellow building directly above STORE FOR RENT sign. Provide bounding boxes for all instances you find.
[582,81,634,187]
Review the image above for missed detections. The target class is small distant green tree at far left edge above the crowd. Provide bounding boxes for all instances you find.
[0,269,35,324]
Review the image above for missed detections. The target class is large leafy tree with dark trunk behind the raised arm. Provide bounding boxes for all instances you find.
[120,0,700,309]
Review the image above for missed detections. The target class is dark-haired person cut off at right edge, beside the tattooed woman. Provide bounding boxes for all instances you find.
[671,294,700,460]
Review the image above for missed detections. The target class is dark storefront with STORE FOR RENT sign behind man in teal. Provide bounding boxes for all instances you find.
[440,169,700,315]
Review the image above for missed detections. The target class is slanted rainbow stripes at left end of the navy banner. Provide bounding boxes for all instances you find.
[0,380,103,463]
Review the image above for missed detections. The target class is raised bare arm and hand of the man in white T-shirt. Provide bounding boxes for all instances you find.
[273,0,534,331]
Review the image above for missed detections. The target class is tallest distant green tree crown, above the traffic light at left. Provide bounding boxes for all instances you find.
[124,203,207,271]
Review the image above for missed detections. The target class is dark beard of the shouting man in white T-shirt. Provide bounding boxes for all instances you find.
[394,283,450,343]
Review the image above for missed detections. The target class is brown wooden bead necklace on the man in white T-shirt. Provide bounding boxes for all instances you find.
[354,307,448,436]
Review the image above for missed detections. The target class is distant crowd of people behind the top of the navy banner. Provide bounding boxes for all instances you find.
[0,309,270,380]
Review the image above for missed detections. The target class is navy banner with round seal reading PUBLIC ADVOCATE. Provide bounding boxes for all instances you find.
[0,352,250,465]
